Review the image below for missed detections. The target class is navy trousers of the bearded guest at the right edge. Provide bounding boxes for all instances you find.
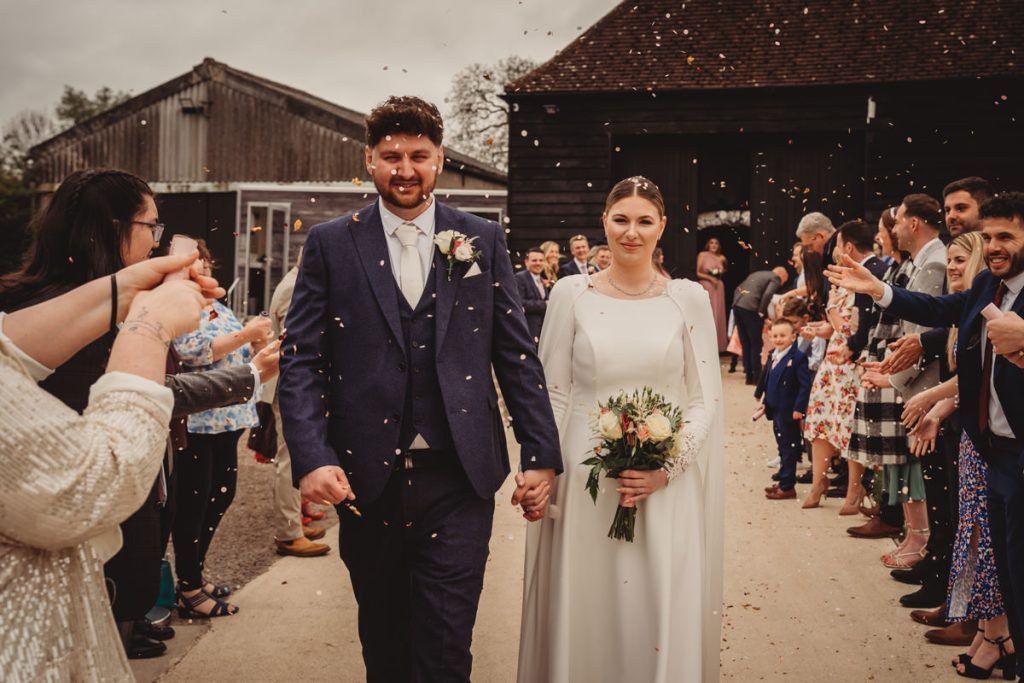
[983,451,1024,675]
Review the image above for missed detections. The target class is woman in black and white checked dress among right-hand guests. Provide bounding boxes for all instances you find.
[846,207,912,540]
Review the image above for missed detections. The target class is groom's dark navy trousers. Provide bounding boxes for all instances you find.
[337,452,495,683]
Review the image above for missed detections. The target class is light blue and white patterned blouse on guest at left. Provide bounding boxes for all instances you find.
[174,301,260,434]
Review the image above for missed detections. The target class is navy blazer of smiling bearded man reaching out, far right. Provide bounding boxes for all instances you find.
[889,270,1024,444]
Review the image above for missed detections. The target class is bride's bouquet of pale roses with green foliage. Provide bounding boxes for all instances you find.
[583,387,683,543]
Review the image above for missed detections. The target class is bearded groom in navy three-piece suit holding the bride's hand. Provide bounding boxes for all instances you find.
[279,97,561,682]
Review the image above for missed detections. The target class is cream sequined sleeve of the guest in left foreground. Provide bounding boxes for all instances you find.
[0,347,173,551]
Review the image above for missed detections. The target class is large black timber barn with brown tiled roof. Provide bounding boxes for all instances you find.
[506,0,1024,294]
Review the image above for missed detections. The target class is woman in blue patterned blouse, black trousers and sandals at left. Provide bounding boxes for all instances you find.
[172,241,278,617]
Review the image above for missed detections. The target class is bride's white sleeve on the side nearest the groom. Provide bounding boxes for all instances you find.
[538,275,583,436]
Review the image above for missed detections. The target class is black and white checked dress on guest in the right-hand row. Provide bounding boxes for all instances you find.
[843,259,913,467]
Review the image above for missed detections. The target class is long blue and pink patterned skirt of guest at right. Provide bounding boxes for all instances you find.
[946,432,1007,622]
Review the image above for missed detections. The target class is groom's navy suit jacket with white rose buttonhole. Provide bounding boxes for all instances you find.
[278,203,561,502]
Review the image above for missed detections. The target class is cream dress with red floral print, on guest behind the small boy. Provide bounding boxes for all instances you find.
[804,288,859,452]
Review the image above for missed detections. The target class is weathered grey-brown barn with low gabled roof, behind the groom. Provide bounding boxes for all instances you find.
[30,58,506,314]
